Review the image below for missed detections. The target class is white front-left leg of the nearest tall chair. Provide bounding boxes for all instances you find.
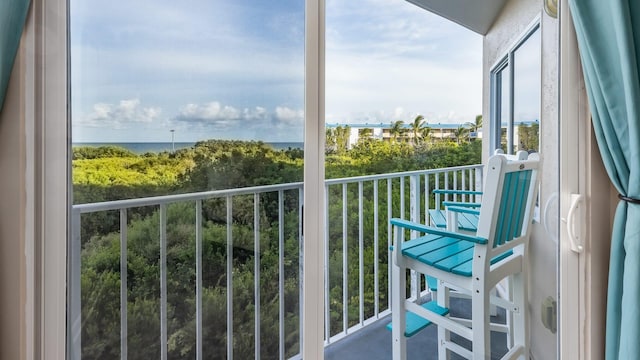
[391,264,407,360]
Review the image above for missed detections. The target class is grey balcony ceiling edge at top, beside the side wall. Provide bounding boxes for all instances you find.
[406,0,506,35]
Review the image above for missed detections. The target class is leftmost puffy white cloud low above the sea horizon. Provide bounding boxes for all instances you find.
[74,98,162,129]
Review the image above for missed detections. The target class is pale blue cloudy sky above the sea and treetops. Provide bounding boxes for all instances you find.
[71,0,482,142]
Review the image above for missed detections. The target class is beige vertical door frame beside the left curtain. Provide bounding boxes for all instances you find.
[20,0,68,359]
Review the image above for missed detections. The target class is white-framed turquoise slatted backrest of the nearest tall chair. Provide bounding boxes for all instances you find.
[477,152,540,252]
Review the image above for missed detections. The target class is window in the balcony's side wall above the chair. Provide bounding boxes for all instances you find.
[490,23,541,154]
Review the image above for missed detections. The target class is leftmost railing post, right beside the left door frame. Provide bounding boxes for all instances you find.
[68,209,82,360]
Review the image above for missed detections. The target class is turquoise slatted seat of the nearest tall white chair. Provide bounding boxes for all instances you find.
[402,235,512,277]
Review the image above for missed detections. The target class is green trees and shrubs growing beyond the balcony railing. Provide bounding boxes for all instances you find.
[73,137,481,359]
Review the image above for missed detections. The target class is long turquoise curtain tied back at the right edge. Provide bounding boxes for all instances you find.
[569,0,640,359]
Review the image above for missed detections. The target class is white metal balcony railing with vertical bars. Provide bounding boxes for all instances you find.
[69,165,483,359]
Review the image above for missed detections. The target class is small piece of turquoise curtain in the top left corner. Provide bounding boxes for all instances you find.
[0,0,30,111]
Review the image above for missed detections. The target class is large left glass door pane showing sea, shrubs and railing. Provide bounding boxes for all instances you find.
[70,0,305,359]
